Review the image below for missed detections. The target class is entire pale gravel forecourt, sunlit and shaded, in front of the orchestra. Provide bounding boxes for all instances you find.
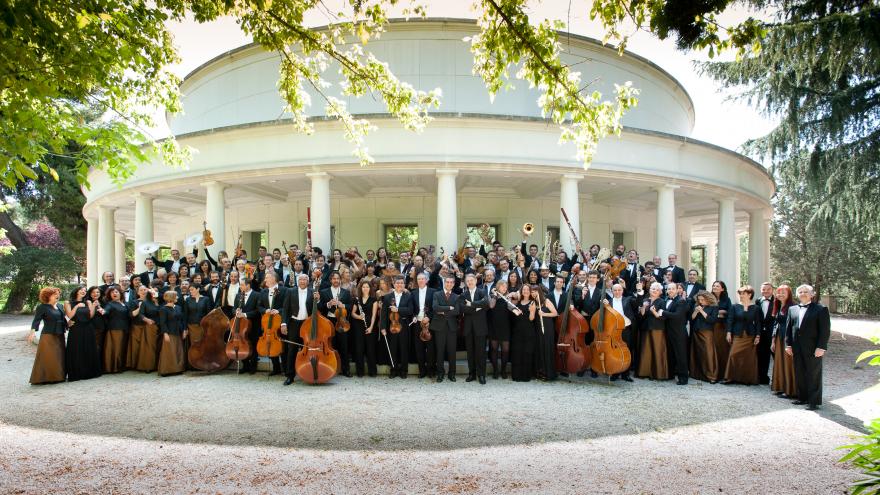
[0,317,880,494]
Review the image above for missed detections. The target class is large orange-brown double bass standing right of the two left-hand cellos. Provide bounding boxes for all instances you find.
[295,270,339,384]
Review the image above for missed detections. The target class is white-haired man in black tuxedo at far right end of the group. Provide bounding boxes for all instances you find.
[785,285,831,411]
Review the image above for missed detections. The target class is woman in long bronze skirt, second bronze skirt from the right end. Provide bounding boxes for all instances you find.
[724,285,761,385]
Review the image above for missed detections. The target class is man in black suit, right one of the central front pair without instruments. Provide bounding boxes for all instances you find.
[459,273,489,385]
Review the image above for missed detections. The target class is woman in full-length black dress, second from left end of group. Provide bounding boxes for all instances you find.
[64,287,101,382]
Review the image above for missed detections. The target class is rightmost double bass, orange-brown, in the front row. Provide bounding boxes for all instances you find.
[590,269,632,375]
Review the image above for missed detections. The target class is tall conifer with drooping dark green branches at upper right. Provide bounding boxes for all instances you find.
[701,0,880,233]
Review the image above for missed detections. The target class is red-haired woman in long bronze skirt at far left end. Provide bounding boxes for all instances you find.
[28,287,67,385]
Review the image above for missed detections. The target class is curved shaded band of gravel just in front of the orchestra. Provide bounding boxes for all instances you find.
[0,326,876,451]
